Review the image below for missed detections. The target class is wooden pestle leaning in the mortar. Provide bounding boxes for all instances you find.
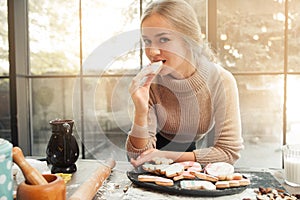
[12,147,48,185]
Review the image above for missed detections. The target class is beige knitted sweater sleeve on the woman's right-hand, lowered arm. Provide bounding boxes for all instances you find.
[194,69,243,164]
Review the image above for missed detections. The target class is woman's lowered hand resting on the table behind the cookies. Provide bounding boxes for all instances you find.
[130,149,164,167]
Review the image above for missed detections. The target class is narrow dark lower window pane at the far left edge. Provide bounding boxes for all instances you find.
[0,79,11,141]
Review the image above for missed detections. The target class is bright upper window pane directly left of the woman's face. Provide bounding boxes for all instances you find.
[82,0,140,74]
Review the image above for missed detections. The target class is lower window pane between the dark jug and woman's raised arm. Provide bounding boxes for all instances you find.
[75,76,133,160]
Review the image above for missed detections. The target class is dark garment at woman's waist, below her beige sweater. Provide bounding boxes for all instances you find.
[156,133,196,152]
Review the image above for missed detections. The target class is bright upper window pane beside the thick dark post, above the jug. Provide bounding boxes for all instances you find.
[28,0,80,75]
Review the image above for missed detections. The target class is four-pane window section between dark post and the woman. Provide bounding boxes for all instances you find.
[28,0,140,158]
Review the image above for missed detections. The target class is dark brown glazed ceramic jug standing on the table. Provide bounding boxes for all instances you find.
[46,119,79,173]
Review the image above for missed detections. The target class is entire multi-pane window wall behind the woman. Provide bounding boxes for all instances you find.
[4,0,300,167]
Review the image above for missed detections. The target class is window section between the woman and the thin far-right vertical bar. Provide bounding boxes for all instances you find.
[217,0,285,167]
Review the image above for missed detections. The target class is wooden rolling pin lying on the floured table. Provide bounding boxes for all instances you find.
[69,159,116,200]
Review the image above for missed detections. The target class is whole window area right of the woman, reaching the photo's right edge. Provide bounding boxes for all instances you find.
[217,0,300,167]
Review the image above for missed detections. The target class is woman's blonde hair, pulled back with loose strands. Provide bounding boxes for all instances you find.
[141,0,216,64]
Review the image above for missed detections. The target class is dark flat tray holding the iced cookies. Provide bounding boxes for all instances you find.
[127,170,247,197]
